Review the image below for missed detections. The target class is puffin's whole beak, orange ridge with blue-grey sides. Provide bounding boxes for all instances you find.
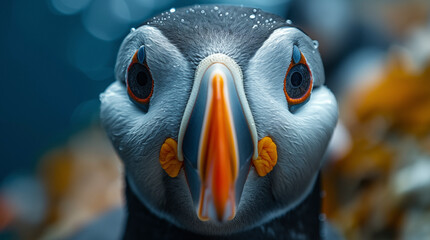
[182,63,254,222]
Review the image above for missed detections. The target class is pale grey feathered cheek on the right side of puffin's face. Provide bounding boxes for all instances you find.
[244,28,338,219]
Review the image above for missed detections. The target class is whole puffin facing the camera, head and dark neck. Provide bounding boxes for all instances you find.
[100,5,338,239]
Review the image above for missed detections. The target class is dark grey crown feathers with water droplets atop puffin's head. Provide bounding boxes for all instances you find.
[144,5,291,69]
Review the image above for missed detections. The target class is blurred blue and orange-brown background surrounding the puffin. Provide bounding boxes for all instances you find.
[0,0,430,239]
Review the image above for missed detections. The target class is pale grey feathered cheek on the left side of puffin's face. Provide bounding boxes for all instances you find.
[101,26,195,227]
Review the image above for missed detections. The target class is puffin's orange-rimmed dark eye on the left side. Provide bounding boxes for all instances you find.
[126,46,154,107]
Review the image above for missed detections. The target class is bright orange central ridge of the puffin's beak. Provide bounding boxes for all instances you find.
[198,72,239,221]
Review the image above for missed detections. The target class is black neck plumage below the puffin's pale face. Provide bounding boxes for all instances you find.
[123,178,320,240]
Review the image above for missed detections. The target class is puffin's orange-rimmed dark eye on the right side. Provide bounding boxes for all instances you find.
[284,45,313,105]
